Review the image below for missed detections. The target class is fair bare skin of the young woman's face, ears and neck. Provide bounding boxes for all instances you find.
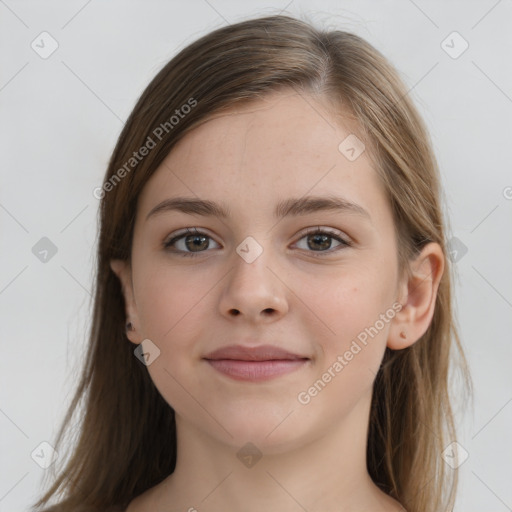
[111,90,444,512]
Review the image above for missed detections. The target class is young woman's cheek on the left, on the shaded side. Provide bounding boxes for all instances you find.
[134,264,222,422]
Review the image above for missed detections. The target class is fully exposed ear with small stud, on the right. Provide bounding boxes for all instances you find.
[387,242,445,350]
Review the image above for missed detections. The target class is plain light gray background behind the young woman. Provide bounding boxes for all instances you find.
[0,0,512,512]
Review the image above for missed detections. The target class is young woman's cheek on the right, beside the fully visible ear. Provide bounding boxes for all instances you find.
[302,260,396,396]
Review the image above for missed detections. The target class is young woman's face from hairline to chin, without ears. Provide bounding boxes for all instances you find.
[118,91,406,452]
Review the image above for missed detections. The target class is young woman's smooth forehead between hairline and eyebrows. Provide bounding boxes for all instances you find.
[139,87,384,222]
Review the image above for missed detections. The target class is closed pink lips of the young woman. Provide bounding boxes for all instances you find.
[204,345,309,381]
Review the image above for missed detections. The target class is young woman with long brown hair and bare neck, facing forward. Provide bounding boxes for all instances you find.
[32,12,469,512]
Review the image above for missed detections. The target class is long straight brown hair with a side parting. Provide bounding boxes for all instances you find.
[34,15,471,512]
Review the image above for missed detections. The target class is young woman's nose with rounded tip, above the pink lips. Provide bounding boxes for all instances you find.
[219,241,288,323]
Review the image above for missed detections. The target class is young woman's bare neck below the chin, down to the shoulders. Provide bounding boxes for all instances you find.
[144,395,403,512]
